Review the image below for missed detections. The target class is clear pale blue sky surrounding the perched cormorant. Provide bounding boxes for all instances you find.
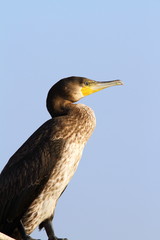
[0,0,160,240]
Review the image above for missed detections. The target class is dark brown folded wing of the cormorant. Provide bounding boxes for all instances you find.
[0,119,65,232]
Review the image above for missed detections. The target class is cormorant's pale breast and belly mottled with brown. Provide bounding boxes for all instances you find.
[22,104,96,234]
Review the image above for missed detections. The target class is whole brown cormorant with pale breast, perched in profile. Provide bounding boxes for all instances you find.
[0,77,122,240]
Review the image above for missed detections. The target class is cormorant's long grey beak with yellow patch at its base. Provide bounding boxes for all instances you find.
[81,80,123,96]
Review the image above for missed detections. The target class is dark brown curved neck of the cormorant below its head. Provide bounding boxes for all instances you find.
[47,95,74,118]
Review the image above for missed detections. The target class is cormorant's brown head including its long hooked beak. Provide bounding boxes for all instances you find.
[47,76,123,115]
